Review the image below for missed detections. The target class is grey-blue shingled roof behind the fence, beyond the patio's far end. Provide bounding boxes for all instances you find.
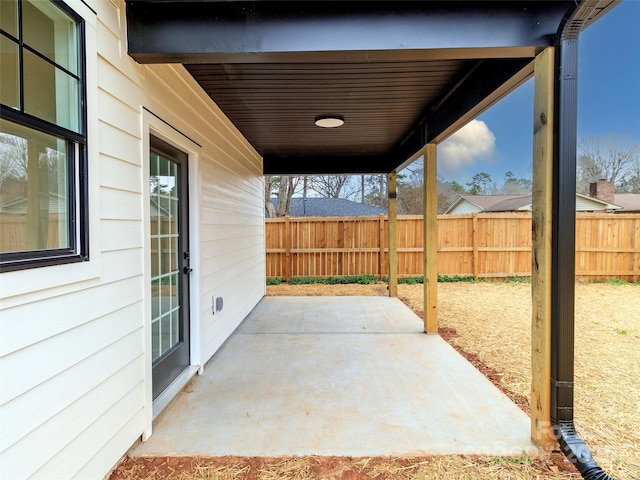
[267,198,387,217]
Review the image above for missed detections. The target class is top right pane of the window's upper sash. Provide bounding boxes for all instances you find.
[22,0,78,75]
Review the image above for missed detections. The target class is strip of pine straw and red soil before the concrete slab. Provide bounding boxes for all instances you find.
[110,456,579,480]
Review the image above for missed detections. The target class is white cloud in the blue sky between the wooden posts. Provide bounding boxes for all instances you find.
[438,120,497,177]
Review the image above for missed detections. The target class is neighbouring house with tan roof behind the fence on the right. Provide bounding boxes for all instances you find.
[444,193,622,215]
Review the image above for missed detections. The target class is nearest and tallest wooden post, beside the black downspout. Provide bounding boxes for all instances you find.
[531,47,556,451]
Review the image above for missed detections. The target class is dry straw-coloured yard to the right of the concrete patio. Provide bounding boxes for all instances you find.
[399,283,640,480]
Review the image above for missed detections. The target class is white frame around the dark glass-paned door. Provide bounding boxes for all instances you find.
[141,107,202,441]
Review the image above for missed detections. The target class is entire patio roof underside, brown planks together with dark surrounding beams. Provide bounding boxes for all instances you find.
[122,0,615,174]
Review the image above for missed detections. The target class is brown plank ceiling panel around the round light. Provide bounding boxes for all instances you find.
[185,60,472,156]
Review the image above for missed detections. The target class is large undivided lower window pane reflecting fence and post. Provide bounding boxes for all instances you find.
[0,119,71,253]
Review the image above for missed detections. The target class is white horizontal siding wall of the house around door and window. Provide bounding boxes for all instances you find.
[0,0,265,479]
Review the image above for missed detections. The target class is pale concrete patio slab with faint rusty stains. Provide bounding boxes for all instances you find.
[130,297,538,456]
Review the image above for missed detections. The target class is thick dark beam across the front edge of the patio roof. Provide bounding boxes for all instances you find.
[126,0,573,63]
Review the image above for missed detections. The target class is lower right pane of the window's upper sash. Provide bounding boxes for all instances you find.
[24,50,79,132]
